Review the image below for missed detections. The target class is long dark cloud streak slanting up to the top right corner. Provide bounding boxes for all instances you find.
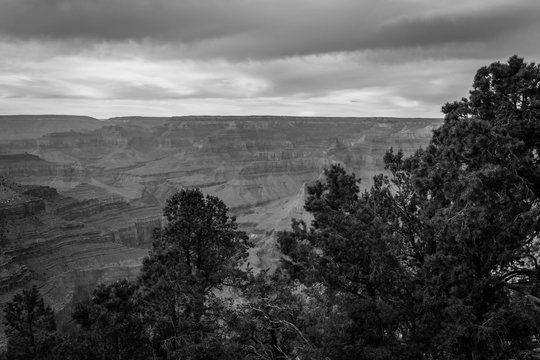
[191,3,540,59]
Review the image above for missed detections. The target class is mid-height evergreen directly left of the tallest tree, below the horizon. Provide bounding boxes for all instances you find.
[278,165,421,359]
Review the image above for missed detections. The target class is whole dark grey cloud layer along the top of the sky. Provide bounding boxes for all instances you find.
[0,0,540,60]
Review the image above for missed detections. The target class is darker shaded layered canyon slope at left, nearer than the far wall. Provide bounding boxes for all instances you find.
[0,178,152,345]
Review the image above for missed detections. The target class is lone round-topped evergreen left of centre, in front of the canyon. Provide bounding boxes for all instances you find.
[139,189,247,359]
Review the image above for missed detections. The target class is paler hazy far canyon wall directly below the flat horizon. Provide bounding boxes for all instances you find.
[0,116,440,243]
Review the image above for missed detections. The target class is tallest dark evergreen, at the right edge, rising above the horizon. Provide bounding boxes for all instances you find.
[408,56,540,359]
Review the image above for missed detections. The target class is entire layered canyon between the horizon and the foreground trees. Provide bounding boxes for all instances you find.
[0,115,442,344]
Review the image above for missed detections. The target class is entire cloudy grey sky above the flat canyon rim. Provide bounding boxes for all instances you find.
[0,0,540,118]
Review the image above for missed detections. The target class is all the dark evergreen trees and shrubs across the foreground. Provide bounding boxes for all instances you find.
[4,57,540,360]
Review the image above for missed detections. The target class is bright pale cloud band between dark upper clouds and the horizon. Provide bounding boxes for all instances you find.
[0,46,478,117]
